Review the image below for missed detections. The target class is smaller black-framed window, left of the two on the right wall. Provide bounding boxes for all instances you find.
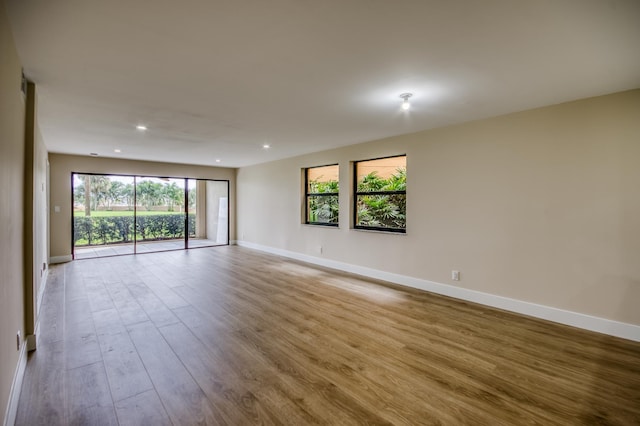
[305,164,339,226]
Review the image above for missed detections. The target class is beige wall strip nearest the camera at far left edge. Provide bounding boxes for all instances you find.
[0,5,25,417]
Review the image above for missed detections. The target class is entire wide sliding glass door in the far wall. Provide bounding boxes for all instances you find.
[72,173,229,259]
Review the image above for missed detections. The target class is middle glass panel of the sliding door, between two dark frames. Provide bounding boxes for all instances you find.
[135,176,186,253]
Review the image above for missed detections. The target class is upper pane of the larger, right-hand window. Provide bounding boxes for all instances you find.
[356,156,407,192]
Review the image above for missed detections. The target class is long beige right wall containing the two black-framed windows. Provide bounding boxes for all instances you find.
[236,90,640,325]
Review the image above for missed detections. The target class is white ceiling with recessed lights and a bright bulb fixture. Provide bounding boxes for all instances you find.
[6,0,640,167]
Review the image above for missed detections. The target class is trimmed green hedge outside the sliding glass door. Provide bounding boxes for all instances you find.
[73,213,196,246]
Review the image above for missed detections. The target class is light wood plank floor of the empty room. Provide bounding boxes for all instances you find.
[17,246,640,425]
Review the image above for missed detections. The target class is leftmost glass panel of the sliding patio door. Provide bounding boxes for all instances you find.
[72,173,135,259]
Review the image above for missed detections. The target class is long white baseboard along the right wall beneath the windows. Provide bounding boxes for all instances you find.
[237,241,640,342]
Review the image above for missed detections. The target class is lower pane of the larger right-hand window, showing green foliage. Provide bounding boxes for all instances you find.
[356,194,407,229]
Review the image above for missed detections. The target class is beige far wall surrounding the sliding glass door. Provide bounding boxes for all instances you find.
[49,153,236,260]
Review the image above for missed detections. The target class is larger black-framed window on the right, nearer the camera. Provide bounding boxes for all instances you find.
[354,155,407,233]
